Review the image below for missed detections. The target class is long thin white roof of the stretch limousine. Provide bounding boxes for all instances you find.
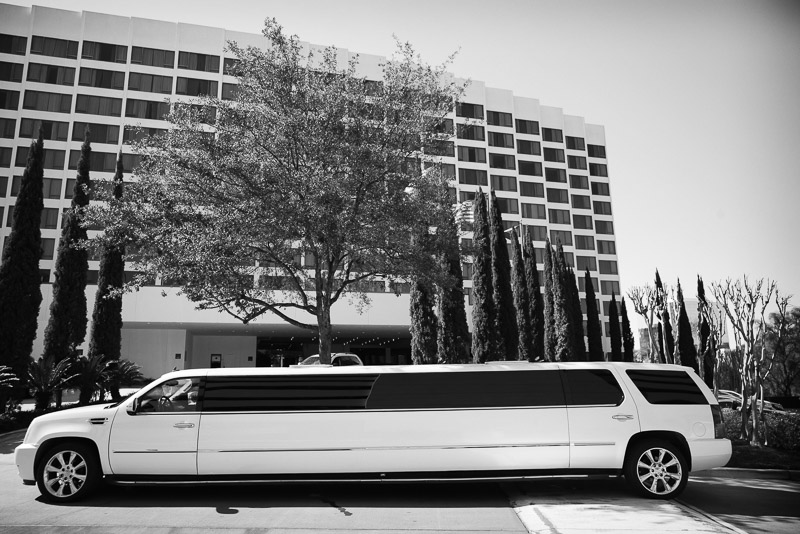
[162,361,692,384]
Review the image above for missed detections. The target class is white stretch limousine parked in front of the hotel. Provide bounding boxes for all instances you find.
[15,362,731,502]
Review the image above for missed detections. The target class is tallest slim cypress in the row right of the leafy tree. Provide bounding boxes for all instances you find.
[472,189,497,363]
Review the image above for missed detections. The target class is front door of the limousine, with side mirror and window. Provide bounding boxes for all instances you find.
[109,378,200,475]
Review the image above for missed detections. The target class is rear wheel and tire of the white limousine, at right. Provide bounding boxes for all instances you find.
[624,440,689,499]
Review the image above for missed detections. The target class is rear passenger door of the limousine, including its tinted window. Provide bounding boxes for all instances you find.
[563,369,639,469]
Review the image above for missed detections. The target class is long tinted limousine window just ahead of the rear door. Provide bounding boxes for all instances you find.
[367,370,564,410]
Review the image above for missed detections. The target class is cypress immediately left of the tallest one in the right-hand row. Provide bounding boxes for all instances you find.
[436,217,470,363]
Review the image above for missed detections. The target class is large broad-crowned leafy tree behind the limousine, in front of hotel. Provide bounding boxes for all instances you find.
[90,20,461,362]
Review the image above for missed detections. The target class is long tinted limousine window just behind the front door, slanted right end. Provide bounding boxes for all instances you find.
[203,375,377,412]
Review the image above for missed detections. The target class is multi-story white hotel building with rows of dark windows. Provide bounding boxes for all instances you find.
[0,4,619,382]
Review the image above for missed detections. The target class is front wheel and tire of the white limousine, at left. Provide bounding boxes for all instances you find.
[35,441,102,503]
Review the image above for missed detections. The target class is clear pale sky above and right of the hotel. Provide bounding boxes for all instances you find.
[2,0,800,319]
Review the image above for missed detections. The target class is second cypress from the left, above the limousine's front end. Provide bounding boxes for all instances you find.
[44,127,92,368]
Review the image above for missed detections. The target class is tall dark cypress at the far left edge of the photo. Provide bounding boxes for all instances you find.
[0,134,44,410]
